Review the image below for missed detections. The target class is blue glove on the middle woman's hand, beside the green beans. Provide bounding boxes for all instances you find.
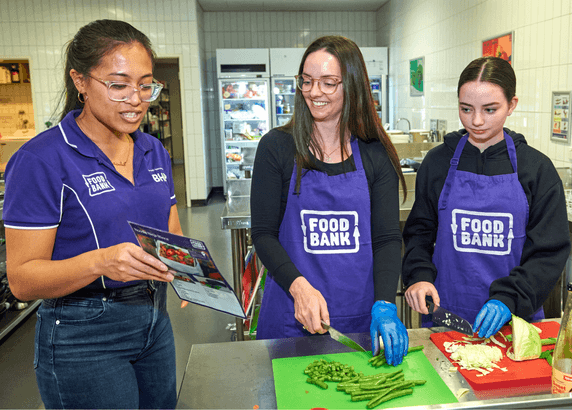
[369,300,409,366]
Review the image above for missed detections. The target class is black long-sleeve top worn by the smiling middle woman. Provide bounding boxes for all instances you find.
[250,129,401,303]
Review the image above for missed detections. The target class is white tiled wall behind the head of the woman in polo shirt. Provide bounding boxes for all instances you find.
[0,0,208,204]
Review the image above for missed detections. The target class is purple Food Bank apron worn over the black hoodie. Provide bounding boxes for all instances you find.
[423,133,544,326]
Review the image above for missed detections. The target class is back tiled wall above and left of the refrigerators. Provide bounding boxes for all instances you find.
[203,11,377,186]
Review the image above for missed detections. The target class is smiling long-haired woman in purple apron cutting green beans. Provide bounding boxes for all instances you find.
[251,36,408,365]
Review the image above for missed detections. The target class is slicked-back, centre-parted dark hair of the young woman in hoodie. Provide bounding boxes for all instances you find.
[457,57,516,102]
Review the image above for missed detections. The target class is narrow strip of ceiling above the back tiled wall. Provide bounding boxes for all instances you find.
[197,0,389,11]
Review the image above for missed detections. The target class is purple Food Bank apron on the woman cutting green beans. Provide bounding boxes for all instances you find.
[256,138,374,339]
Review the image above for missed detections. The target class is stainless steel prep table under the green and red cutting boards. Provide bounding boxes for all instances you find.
[177,327,572,409]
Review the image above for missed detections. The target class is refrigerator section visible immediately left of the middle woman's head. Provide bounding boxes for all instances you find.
[270,48,306,127]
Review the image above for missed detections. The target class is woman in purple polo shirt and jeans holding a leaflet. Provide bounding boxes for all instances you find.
[4,20,182,408]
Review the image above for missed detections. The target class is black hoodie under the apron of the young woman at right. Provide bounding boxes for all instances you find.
[402,128,570,318]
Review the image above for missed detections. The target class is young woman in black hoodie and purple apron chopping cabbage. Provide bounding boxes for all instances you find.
[402,57,570,337]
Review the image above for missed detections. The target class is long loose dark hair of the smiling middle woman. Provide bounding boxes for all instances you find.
[280,36,407,200]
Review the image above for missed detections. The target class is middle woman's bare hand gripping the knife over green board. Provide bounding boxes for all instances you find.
[290,276,330,334]
